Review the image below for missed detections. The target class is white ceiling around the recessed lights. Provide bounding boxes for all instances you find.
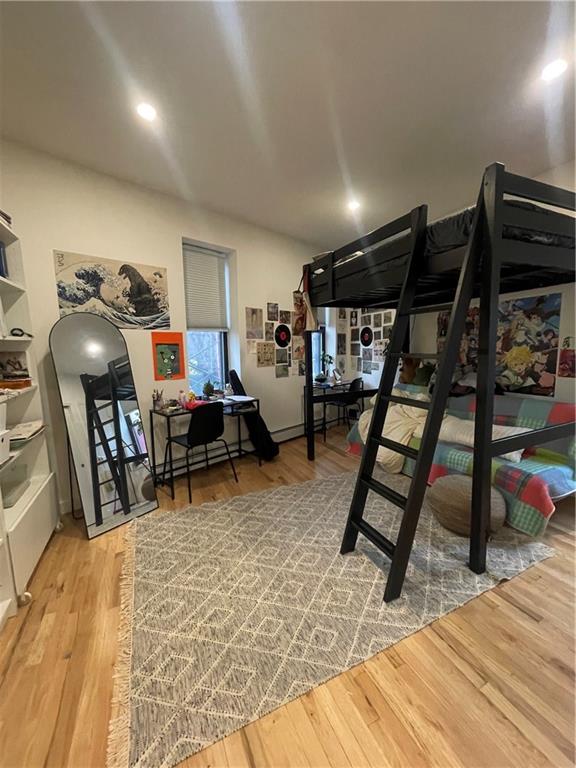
[0,2,574,247]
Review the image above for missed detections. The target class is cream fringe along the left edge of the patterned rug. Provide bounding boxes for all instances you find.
[106,522,136,768]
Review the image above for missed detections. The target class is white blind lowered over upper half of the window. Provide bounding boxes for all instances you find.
[182,243,229,331]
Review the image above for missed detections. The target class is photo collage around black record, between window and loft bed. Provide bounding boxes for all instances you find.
[245,291,306,379]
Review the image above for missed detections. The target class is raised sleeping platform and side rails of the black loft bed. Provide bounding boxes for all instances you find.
[304,181,574,309]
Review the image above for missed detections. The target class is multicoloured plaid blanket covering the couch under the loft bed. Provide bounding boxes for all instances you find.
[348,386,576,536]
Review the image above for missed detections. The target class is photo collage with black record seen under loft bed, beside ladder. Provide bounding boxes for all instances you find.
[350,308,395,374]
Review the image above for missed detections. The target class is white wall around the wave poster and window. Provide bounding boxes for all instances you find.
[0,142,315,512]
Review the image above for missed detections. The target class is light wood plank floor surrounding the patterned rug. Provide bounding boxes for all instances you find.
[0,430,574,768]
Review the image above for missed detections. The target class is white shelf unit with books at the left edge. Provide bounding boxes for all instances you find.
[0,214,59,629]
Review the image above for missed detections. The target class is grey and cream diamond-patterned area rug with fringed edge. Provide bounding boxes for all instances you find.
[108,474,553,768]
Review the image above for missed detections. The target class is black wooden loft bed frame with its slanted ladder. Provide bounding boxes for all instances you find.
[304,163,576,601]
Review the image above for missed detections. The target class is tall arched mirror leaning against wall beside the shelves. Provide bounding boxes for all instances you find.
[50,312,158,538]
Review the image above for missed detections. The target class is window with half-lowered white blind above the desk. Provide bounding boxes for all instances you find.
[183,242,230,394]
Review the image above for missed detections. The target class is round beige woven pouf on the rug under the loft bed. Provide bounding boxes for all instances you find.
[426,475,506,536]
